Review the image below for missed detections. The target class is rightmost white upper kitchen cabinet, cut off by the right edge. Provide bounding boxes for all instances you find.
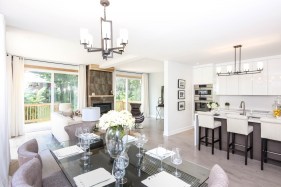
[267,59,281,95]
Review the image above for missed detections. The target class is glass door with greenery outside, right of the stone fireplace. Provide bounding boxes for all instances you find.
[115,77,141,111]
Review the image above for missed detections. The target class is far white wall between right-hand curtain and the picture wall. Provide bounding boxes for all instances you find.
[148,72,165,118]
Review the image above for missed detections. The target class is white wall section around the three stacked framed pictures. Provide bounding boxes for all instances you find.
[164,61,193,136]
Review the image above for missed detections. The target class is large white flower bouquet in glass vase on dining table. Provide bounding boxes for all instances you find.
[98,110,135,130]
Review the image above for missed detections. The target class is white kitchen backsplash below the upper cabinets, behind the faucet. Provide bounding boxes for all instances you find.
[216,96,276,111]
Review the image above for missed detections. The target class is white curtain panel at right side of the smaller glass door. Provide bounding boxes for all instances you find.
[141,73,149,117]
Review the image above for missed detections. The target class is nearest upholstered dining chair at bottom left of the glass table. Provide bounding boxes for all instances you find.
[12,158,43,187]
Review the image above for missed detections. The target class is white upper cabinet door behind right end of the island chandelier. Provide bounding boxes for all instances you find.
[253,61,268,95]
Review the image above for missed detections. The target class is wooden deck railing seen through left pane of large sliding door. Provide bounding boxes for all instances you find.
[24,103,51,124]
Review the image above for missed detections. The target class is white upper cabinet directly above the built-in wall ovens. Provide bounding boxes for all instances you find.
[193,65,214,84]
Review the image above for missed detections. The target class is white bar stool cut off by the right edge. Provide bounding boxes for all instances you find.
[260,117,281,170]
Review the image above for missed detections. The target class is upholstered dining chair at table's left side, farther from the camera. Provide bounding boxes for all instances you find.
[18,139,42,166]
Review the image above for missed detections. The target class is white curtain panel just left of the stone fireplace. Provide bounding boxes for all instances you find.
[78,65,87,110]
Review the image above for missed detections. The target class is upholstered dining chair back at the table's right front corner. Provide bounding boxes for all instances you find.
[208,164,229,187]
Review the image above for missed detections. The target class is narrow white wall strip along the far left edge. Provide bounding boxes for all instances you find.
[0,14,10,186]
